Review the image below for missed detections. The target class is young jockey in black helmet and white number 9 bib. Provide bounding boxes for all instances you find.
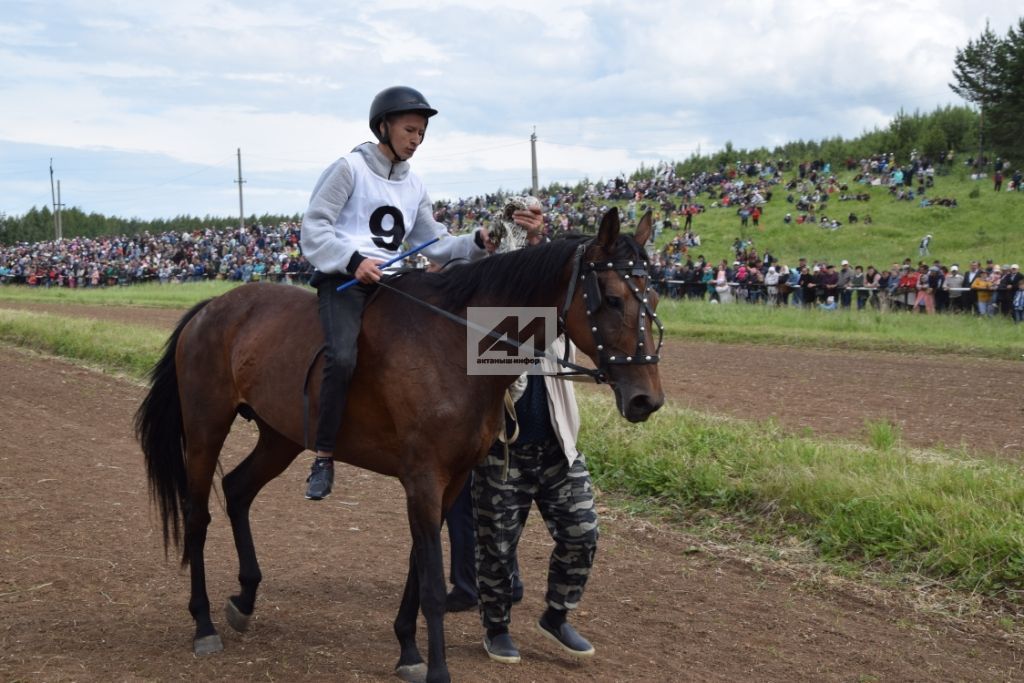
[300,86,541,501]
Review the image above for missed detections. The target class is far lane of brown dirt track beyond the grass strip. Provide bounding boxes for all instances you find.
[8,302,1024,460]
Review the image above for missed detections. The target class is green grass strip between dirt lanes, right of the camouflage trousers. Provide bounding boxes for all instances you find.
[580,393,1024,603]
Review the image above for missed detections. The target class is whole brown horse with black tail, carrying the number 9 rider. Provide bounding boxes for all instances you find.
[135,209,664,681]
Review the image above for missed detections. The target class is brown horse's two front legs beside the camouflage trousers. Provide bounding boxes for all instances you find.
[394,475,452,683]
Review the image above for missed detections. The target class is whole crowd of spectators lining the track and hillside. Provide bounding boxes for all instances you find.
[0,155,1024,318]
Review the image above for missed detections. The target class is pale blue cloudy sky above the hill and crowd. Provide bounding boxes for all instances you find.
[0,0,1024,218]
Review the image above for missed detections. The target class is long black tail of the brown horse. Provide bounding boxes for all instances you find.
[134,299,211,565]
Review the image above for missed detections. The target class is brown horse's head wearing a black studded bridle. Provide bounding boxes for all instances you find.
[563,208,665,422]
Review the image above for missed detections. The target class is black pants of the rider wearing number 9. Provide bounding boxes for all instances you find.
[314,278,376,453]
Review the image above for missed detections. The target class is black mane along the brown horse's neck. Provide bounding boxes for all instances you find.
[400,236,586,311]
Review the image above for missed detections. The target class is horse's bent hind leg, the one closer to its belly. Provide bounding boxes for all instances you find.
[222,421,302,633]
